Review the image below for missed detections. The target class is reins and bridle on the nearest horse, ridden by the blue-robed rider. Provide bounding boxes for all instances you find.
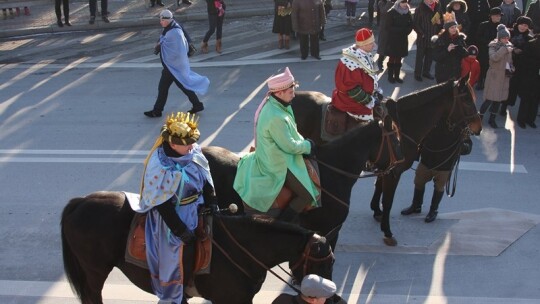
[212,217,334,293]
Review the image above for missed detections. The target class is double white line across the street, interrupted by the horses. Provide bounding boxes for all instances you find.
[0,149,528,173]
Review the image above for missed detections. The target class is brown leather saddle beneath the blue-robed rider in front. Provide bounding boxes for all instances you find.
[125,213,212,275]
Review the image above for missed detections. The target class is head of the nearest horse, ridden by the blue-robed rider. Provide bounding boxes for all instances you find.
[289,234,335,283]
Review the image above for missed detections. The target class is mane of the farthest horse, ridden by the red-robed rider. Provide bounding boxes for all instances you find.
[397,80,454,112]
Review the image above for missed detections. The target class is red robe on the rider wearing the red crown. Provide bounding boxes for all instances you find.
[332,60,374,115]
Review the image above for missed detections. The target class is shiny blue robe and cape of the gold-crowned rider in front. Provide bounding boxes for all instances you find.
[136,144,213,303]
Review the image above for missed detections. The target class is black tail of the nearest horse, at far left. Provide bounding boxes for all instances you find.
[60,197,90,300]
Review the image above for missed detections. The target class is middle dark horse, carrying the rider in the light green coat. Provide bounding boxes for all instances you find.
[203,122,382,248]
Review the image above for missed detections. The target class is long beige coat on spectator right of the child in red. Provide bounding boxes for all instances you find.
[484,39,513,101]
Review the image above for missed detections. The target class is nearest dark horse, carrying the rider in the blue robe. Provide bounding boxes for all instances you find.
[61,192,334,304]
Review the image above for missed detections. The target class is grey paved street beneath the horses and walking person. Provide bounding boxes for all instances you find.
[0,10,540,304]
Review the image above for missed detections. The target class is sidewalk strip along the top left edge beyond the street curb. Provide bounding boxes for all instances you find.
[0,0,274,38]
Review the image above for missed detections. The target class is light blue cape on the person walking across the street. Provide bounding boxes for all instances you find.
[159,20,210,94]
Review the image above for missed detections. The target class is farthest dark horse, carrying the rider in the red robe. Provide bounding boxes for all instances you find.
[292,76,482,246]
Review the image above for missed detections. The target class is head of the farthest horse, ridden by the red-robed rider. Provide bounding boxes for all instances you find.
[447,75,482,135]
